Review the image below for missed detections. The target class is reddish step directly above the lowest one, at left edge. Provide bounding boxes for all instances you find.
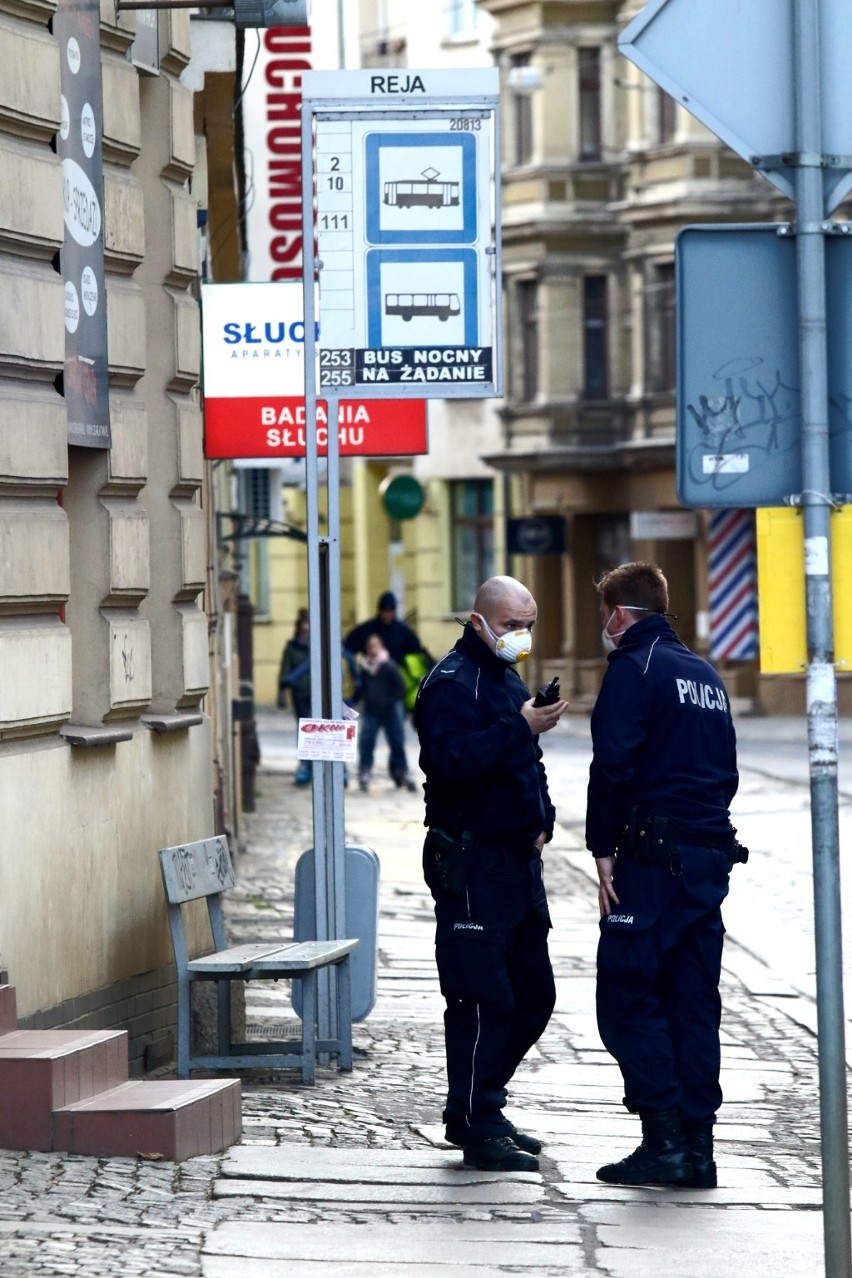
[0,1030,128,1151]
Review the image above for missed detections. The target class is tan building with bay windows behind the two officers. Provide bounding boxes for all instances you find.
[480,0,848,712]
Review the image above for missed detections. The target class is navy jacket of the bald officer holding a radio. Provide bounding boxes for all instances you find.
[414,622,556,843]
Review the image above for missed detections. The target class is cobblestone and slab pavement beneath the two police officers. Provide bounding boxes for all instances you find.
[0,713,848,1278]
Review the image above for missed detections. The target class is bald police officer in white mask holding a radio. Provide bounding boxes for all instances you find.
[414,576,566,1171]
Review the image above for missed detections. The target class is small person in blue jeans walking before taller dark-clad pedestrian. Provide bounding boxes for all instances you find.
[358,635,416,791]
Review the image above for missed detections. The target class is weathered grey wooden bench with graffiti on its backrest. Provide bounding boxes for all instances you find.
[160,836,358,1082]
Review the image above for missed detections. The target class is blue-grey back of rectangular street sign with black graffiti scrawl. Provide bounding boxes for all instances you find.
[674,224,852,509]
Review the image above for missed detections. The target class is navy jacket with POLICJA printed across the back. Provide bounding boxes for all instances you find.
[586,613,738,856]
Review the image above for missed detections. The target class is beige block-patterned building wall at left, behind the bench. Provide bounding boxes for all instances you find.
[0,0,223,1072]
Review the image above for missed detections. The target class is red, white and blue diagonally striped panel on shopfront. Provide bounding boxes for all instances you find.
[709,510,757,661]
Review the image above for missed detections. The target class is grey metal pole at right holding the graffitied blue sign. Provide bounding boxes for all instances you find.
[795,0,852,1278]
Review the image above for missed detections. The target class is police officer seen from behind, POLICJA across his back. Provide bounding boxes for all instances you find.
[586,564,747,1189]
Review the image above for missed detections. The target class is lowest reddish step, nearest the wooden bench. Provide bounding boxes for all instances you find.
[54,1079,243,1163]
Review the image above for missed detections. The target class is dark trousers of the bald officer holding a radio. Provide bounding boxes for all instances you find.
[424,845,556,1141]
